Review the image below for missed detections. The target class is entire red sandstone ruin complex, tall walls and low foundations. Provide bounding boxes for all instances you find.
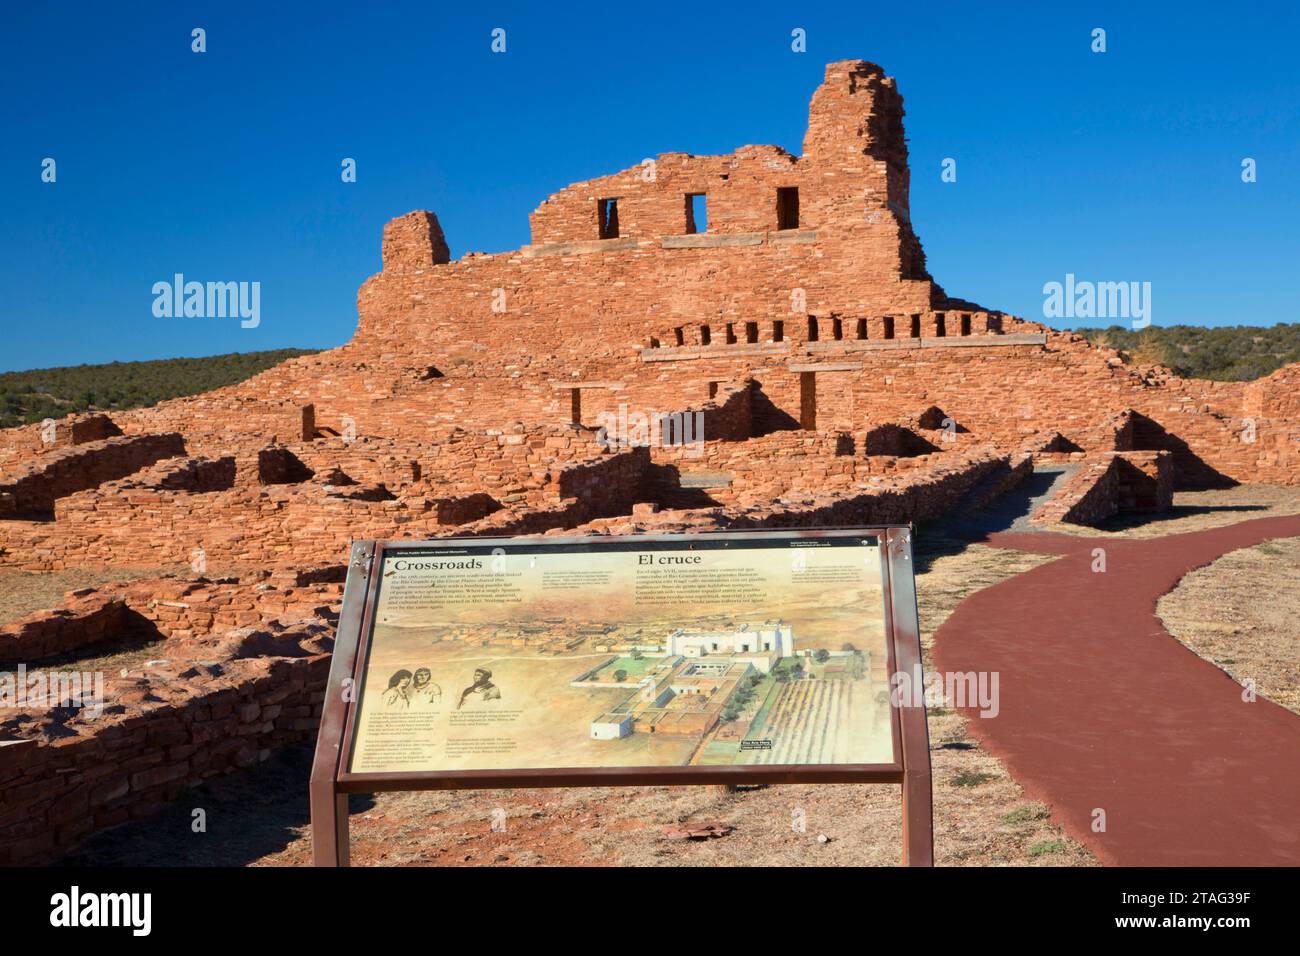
[0,60,1300,864]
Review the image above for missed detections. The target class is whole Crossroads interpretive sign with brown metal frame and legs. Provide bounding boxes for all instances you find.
[312,528,930,864]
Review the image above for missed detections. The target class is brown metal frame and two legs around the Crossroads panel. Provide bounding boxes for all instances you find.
[309,525,933,866]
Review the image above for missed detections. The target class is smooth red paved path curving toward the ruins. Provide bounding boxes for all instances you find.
[935,516,1300,866]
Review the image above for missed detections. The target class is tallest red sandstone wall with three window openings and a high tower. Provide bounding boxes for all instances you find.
[358,61,944,363]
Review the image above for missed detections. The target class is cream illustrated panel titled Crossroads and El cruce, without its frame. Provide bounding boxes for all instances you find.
[350,535,894,774]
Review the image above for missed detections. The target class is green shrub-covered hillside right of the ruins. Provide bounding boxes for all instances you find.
[1076,323,1300,381]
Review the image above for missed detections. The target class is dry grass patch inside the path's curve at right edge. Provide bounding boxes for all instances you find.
[1156,537,1300,714]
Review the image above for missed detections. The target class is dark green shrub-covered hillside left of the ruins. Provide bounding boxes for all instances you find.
[0,349,315,428]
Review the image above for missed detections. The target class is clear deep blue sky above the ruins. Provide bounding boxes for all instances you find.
[0,3,1300,371]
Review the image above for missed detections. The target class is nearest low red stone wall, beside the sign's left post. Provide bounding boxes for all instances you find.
[0,642,330,866]
